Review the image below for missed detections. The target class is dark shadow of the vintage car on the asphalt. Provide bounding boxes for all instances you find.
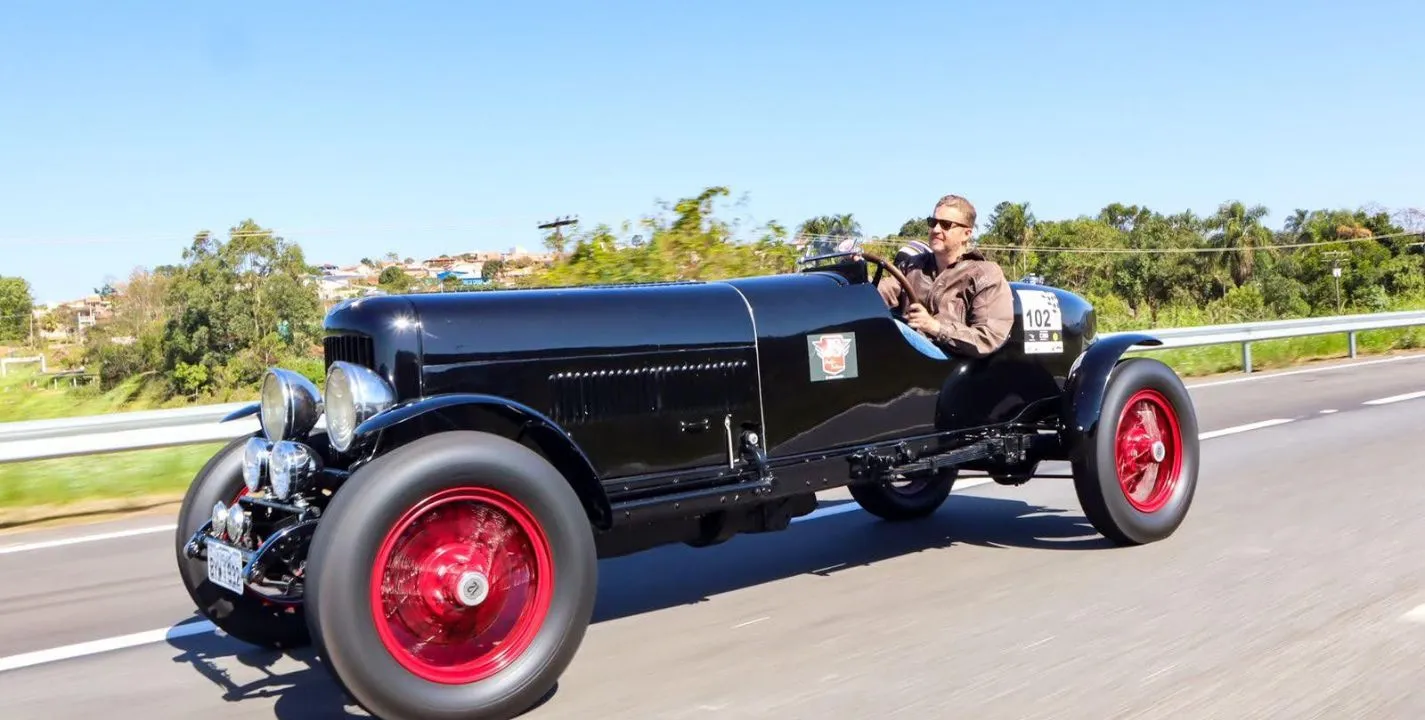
[168,495,1112,720]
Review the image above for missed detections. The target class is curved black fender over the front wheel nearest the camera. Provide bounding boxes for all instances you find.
[356,394,613,529]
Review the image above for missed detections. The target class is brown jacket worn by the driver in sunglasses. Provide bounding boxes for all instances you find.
[876,250,1015,358]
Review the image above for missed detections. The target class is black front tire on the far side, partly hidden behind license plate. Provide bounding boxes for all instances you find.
[174,435,311,650]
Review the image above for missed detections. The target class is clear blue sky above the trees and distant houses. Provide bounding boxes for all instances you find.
[0,0,1425,302]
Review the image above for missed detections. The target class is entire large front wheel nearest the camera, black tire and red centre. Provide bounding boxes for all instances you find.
[308,432,597,720]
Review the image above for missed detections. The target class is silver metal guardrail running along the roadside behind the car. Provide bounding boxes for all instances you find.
[0,311,1425,463]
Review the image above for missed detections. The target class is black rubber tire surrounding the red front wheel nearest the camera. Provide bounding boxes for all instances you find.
[306,432,599,720]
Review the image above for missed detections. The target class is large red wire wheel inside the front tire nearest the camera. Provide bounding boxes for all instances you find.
[371,488,554,684]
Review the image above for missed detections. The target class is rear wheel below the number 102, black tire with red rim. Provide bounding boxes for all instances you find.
[1072,358,1200,545]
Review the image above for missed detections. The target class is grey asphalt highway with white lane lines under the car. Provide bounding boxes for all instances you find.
[0,350,1425,720]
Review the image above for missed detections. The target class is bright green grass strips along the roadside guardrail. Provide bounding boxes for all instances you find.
[0,322,1425,528]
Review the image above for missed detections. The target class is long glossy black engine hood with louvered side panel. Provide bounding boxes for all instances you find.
[328,282,761,479]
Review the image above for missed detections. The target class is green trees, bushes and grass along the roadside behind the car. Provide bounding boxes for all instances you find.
[0,187,1425,526]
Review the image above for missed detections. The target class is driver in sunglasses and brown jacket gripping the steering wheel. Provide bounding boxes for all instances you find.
[876,195,1015,358]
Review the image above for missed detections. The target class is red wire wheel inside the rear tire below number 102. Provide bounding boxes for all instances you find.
[1114,388,1183,513]
